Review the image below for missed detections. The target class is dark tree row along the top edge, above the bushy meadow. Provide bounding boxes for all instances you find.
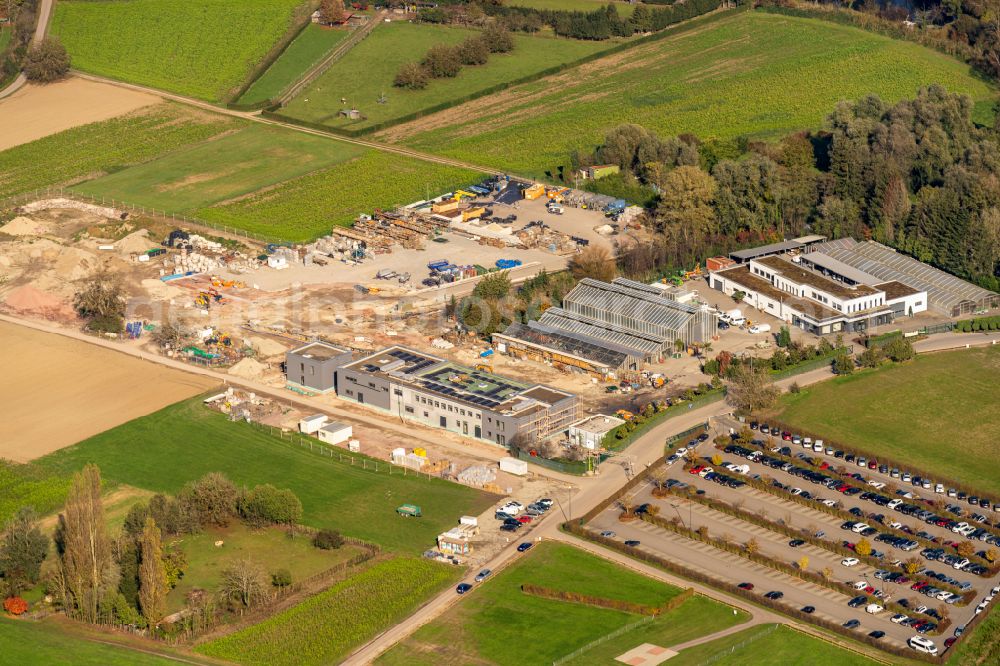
[418,0,722,40]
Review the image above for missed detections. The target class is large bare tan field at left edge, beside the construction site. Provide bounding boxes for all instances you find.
[0,322,218,462]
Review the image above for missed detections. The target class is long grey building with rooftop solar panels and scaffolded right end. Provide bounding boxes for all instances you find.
[336,346,577,446]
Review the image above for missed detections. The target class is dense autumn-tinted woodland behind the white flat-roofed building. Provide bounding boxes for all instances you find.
[570,85,1000,291]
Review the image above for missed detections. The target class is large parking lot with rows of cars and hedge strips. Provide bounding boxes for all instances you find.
[589,420,1000,649]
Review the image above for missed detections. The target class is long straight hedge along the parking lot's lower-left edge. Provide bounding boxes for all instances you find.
[562,522,944,664]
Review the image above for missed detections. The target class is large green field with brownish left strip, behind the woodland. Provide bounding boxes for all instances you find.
[386,11,996,176]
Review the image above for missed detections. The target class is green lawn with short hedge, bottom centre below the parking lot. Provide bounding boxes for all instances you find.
[377,543,747,666]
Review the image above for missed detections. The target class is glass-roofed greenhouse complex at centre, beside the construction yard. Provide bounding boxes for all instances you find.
[494,278,718,376]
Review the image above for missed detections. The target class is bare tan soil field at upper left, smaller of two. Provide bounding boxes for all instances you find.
[0,77,162,150]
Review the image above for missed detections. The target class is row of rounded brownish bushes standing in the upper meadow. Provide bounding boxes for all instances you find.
[393,21,514,90]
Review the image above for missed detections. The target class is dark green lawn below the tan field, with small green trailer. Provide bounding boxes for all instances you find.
[33,398,494,553]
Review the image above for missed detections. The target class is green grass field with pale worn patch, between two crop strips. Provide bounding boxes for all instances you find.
[74,124,365,213]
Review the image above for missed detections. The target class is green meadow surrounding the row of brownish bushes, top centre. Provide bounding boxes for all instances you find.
[282,22,611,129]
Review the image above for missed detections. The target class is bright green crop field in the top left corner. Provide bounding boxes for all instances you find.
[51,0,308,101]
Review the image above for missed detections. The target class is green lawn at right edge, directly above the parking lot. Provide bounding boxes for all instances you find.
[779,347,1000,495]
